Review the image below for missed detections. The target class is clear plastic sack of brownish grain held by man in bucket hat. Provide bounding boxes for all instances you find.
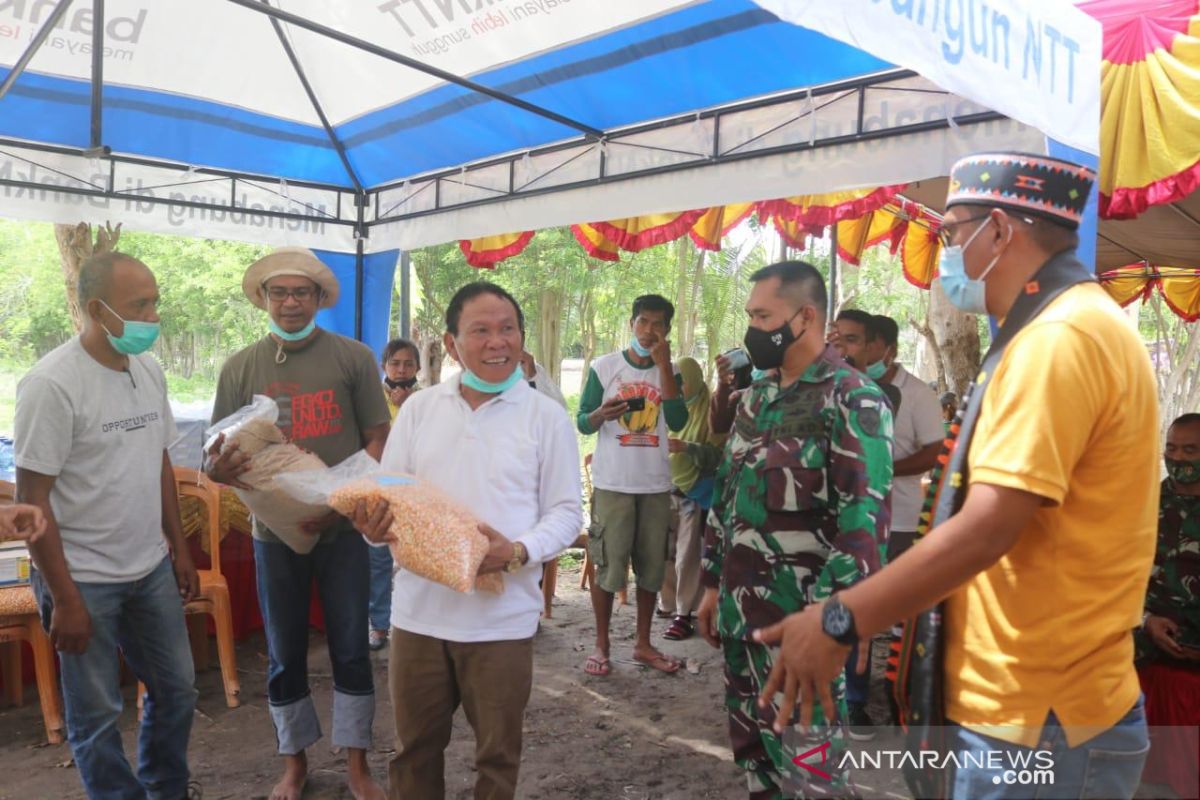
[204,395,329,553]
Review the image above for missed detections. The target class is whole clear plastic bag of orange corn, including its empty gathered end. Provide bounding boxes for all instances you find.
[278,452,504,593]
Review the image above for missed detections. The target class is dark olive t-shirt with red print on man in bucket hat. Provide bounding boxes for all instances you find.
[212,329,390,541]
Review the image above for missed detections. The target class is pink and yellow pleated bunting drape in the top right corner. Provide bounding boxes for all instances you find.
[1079,0,1200,219]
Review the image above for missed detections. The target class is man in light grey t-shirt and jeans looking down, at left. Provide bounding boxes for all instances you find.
[14,253,199,800]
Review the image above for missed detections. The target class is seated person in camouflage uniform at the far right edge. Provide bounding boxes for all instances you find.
[1135,414,1200,667]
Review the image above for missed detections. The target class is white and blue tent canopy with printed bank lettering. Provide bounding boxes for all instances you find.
[0,0,1100,352]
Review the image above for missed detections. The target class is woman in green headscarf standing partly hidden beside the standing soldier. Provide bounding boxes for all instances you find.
[659,359,725,640]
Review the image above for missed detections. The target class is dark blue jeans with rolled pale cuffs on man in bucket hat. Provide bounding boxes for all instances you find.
[254,525,374,756]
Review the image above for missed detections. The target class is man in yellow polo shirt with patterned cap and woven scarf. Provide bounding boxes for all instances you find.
[758,154,1159,800]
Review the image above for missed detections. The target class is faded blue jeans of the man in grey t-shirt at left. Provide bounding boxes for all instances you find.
[32,559,197,800]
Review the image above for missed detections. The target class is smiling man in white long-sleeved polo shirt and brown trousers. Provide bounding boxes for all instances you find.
[354,282,583,800]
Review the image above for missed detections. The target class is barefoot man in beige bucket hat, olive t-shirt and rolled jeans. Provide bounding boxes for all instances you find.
[208,247,390,800]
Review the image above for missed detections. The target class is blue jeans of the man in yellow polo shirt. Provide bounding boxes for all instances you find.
[950,696,1150,800]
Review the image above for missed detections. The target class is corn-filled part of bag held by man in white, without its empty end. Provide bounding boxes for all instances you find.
[329,473,504,593]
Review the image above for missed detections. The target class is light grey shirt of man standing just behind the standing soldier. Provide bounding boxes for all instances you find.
[892,365,946,531]
